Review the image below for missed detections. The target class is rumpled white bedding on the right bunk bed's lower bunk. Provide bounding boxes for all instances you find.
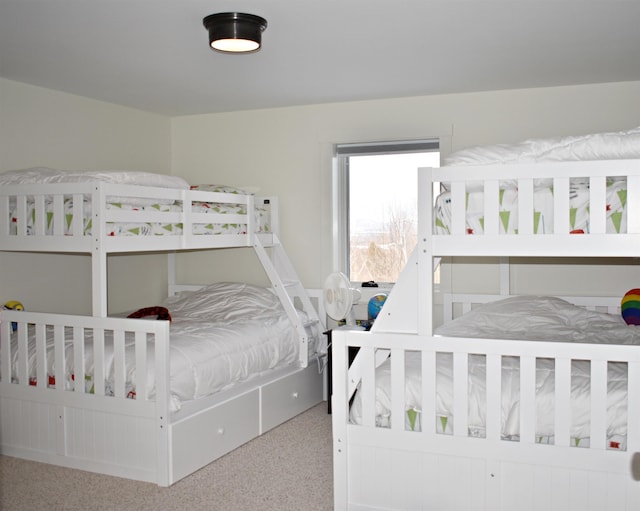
[349,297,640,449]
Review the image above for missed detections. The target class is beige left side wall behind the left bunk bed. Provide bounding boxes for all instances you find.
[0,79,171,314]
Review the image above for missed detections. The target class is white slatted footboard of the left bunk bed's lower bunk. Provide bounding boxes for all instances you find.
[0,311,169,486]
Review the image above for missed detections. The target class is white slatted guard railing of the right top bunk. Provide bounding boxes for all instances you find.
[419,160,640,257]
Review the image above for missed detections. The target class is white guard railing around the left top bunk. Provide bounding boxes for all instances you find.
[0,182,278,253]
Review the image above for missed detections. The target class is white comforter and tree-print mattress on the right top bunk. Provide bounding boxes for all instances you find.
[434,128,640,239]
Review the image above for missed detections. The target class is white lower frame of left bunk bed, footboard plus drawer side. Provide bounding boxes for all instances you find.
[0,304,323,486]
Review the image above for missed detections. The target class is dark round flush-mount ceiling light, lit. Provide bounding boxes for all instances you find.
[202,12,267,53]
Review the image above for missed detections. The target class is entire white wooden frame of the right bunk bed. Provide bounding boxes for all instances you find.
[332,160,640,511]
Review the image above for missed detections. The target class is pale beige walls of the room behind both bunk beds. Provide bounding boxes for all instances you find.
[0,80,640,313]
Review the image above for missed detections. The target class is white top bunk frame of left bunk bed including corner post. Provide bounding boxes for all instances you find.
[0,182,278,317]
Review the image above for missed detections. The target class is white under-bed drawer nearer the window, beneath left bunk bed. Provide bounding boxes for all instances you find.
[262,362,322,433]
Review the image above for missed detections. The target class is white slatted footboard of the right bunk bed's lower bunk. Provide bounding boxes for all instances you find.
[332,330,640,510]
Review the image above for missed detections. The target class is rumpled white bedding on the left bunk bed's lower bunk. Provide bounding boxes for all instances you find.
[5,283,316,412]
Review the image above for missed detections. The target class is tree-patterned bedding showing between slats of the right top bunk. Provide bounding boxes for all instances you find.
[434,179,627,234]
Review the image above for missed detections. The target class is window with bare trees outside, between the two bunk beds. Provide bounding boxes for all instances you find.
[334,140,440,283]
